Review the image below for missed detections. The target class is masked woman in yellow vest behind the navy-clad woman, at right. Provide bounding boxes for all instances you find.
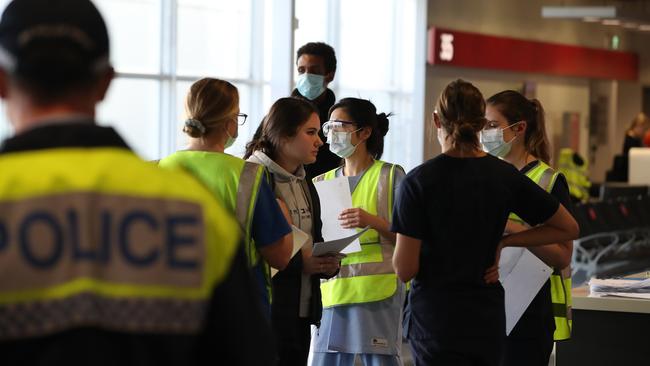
[481,90,573,366]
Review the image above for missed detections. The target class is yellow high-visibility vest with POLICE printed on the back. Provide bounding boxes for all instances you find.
[0,147,239,339]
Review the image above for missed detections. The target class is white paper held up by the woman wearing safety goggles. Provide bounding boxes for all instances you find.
[314,177,361,254]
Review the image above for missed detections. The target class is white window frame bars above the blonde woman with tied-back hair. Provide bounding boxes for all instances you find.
[109,0,294,157]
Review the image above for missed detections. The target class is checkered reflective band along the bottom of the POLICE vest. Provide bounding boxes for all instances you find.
[0,293,207,340]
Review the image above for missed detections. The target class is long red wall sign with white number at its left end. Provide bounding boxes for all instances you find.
[427,27,639,80]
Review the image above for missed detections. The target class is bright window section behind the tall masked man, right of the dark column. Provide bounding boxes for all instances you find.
[295,0,424,169]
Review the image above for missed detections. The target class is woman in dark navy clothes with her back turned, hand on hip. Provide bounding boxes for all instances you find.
[391,80,579,366]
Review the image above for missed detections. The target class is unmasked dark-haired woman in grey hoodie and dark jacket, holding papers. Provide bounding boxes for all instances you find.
[245,97,340,366]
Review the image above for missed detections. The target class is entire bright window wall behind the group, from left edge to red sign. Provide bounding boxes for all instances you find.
[0,0,426,168]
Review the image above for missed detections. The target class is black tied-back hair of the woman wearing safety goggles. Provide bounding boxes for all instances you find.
[329,98,392,160]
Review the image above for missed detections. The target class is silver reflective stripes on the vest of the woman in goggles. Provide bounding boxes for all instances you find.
[333,163,395,280]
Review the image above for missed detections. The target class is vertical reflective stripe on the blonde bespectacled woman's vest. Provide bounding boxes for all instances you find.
[235,161,260,266]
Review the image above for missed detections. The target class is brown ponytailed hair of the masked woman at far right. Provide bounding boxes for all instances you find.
[487,90,551,164]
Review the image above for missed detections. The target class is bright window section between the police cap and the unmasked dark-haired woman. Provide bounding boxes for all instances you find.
[95,0,271,159]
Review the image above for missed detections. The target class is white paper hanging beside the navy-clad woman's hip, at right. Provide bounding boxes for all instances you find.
[499,247,553,335]
